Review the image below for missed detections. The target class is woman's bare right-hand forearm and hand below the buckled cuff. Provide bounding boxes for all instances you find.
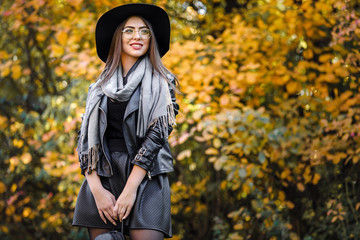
[113,165,146,222]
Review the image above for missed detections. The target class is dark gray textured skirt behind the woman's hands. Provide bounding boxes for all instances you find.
[72,152,172,238]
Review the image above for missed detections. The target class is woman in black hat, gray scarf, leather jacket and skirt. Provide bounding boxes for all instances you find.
[73,4,179,240]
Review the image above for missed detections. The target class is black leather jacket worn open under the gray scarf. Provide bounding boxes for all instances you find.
[81,77,179,179]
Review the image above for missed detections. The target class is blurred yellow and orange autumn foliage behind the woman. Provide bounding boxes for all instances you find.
[0,0,360,240]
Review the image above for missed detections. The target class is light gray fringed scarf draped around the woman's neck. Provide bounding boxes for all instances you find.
[77,57,175,173]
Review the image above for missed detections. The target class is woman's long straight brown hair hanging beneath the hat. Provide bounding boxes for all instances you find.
[100,16,179,91]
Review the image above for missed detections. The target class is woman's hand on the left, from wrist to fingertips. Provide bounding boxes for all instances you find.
[93,187,117,225]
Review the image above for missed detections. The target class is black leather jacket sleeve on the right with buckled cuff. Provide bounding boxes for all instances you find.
[131,76,179,172]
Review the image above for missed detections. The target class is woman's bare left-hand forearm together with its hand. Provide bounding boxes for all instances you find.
[85,171,117,225]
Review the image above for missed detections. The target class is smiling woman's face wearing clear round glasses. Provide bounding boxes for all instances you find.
[121,17,150,61]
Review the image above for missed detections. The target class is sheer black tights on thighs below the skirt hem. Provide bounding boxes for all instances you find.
[88,228,164,240]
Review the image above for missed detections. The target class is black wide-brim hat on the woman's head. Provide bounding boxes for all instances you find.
[95,3,170,62]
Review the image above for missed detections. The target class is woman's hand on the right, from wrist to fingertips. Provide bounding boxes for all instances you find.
[113,188,137,222]
